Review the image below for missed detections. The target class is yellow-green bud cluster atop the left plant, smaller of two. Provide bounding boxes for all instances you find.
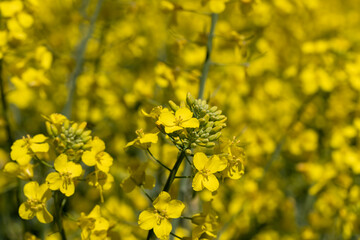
[46,114,91,161]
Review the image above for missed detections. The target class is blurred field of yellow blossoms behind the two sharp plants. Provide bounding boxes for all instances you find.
[0,0,360,240]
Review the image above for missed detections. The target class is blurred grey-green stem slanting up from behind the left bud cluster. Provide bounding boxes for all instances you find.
[63,0,103,118]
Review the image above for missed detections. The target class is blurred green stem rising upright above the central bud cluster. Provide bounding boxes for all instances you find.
[198,13,218,99]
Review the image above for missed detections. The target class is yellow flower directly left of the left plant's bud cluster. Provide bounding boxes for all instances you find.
[10,134,49,165]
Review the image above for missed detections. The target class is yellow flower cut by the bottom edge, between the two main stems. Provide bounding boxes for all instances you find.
[78,205,109,240]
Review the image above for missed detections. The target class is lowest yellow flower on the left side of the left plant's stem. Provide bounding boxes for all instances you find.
[19,181,53,223]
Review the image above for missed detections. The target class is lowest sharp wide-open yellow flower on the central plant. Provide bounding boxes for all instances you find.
[138,192,185,239]
